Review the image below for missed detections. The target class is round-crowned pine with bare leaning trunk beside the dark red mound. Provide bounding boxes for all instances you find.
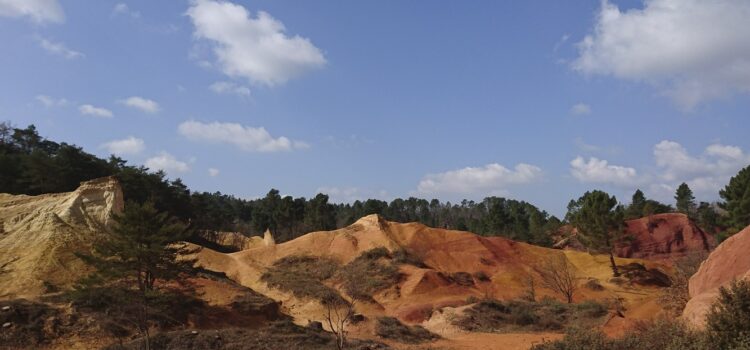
[566,190,624,277]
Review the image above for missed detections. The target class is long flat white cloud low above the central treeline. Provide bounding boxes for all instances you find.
[417,163,542,194]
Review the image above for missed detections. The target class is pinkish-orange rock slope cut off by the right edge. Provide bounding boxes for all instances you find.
[682,226,750,327]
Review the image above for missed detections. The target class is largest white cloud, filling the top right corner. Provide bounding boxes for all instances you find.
[572,0,750,110]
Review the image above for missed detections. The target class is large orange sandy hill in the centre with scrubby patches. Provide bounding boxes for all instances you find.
[192,215,660,334]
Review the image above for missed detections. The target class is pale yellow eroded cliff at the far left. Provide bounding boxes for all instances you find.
[0,177,123,297]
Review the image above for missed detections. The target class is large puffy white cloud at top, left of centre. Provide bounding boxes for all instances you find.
[187,0,326,86]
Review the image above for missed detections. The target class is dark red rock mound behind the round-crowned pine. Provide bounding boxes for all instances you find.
[615,213,716,259]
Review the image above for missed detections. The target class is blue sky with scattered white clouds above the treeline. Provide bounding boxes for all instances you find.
[0,0,750,215]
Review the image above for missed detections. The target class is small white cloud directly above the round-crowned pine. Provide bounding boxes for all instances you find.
[570,156,638,186]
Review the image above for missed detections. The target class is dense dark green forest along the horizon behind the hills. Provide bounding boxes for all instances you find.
[0,123,750,245]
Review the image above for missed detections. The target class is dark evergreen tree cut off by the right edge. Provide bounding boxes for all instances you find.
[719,166,750,234]
